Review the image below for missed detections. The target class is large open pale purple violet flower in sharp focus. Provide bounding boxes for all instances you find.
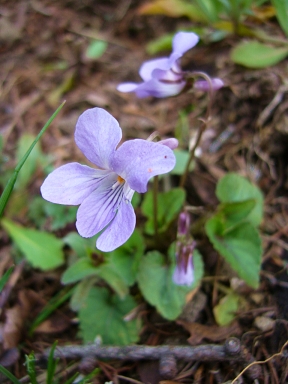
[41,108,178,252]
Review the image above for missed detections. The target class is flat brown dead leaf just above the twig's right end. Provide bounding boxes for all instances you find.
[177,320,241,345]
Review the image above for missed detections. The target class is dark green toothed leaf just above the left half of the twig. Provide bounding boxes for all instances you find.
[79,287,141,345]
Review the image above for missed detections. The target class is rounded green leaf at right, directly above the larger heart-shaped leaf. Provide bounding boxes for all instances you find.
[216,173,263,226]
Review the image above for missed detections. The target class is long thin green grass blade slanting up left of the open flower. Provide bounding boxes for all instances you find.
[0,101,65,217]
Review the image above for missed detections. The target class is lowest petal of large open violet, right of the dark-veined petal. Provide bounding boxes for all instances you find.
[96,199,136,252]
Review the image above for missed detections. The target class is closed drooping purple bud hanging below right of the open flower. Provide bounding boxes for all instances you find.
[173,212,196,286]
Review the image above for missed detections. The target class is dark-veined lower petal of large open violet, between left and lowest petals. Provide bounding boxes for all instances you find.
[76,173,123,237]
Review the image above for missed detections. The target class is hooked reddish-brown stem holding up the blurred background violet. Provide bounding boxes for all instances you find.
[180,72,214,188]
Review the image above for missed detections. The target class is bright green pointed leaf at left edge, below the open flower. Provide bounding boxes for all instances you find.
[1,219,64,270]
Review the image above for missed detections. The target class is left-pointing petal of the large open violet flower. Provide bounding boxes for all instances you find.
[41,163,109,205]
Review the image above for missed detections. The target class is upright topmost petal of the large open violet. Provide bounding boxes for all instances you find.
[75,108,122,169]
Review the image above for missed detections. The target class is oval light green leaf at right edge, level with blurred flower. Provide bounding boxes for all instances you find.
[231,41,288,68]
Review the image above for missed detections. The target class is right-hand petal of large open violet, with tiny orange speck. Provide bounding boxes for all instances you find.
[111,139,176,193]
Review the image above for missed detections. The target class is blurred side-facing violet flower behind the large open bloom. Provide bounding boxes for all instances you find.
[117,32,224,98]
